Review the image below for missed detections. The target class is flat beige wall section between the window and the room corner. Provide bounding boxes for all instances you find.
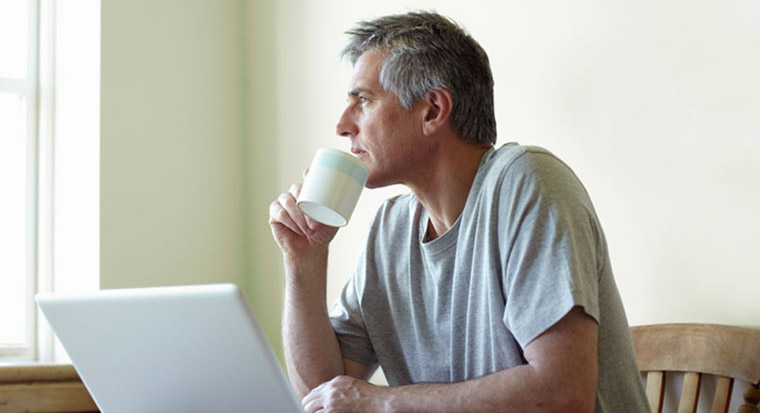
[101,0,245,288]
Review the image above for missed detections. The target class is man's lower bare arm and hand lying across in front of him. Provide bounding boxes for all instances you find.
[303,307,598,412]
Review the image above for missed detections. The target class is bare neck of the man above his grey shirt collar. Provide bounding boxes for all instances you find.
[407,138,491,240]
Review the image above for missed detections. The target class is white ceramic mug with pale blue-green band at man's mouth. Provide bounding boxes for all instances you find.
[297,148,369,227]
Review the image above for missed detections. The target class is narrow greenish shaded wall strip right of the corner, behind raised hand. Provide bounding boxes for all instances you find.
[242,1,287,356]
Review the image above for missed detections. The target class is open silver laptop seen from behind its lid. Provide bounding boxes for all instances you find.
[36,284,303,413]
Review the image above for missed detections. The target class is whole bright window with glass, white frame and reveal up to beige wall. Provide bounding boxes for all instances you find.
[0,0,100,361]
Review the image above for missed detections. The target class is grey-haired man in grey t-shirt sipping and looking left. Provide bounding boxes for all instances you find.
[270,13,648,412]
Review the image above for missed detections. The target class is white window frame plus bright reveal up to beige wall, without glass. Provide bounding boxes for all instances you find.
[0,0,101,364]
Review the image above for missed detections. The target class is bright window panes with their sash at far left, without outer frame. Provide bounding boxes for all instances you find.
[0,1,37,358]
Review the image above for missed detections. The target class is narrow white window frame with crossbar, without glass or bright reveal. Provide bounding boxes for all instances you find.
[0,0,55,362]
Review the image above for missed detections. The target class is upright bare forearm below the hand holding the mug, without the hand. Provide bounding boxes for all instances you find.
[283,250,344,397]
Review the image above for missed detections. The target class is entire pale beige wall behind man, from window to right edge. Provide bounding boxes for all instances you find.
[101,0,760,366]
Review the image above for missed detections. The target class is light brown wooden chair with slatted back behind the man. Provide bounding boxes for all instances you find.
[631,324,760,413]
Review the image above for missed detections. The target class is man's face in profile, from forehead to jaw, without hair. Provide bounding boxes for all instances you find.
[337,51,427,188]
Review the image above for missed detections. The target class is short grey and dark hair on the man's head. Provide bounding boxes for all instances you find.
[341,12,496,144]
